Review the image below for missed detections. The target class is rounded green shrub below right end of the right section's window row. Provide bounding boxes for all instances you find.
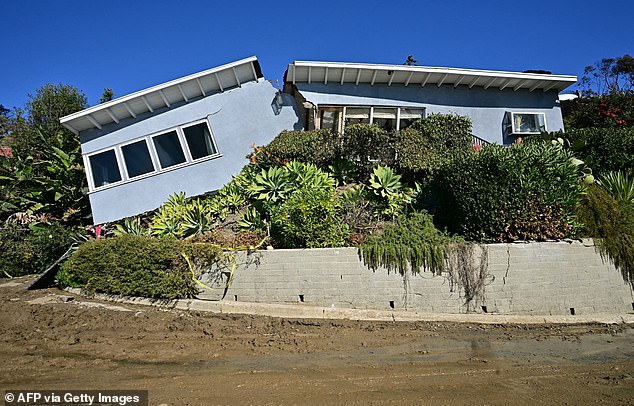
[395,114,473,175]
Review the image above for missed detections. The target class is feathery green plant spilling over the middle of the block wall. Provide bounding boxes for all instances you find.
[359,212,458,274]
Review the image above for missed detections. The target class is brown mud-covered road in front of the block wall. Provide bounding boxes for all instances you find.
[0,279,634,405]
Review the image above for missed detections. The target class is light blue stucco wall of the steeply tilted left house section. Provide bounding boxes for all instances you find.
[80,80,301,224]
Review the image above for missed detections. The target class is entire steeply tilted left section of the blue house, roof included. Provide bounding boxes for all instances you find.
[61,57,301,224]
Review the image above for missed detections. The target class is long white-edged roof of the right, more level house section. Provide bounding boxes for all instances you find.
[285,61,577,92]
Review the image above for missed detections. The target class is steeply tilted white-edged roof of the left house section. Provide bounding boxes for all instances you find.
[60,56,262,134]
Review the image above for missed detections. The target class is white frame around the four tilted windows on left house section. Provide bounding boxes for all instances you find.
[82,119,222,194]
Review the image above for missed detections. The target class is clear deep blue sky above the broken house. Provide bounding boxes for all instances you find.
[0,0,634,108]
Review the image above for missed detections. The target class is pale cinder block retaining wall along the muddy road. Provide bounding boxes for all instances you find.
[199,240,634,315]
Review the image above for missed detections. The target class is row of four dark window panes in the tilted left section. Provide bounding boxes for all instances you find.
[88,121,218,189]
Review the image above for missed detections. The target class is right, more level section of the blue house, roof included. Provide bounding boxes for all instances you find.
[284,61,577,144]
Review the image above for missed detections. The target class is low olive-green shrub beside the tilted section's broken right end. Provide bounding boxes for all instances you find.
[256,130,339,169]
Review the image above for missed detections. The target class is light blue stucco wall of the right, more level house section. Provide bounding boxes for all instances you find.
[296,83,563,144]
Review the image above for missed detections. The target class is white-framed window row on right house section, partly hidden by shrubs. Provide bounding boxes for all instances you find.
[317,106,425,133]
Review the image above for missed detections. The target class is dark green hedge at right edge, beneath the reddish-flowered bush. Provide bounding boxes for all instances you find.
[559,126,634,175]
